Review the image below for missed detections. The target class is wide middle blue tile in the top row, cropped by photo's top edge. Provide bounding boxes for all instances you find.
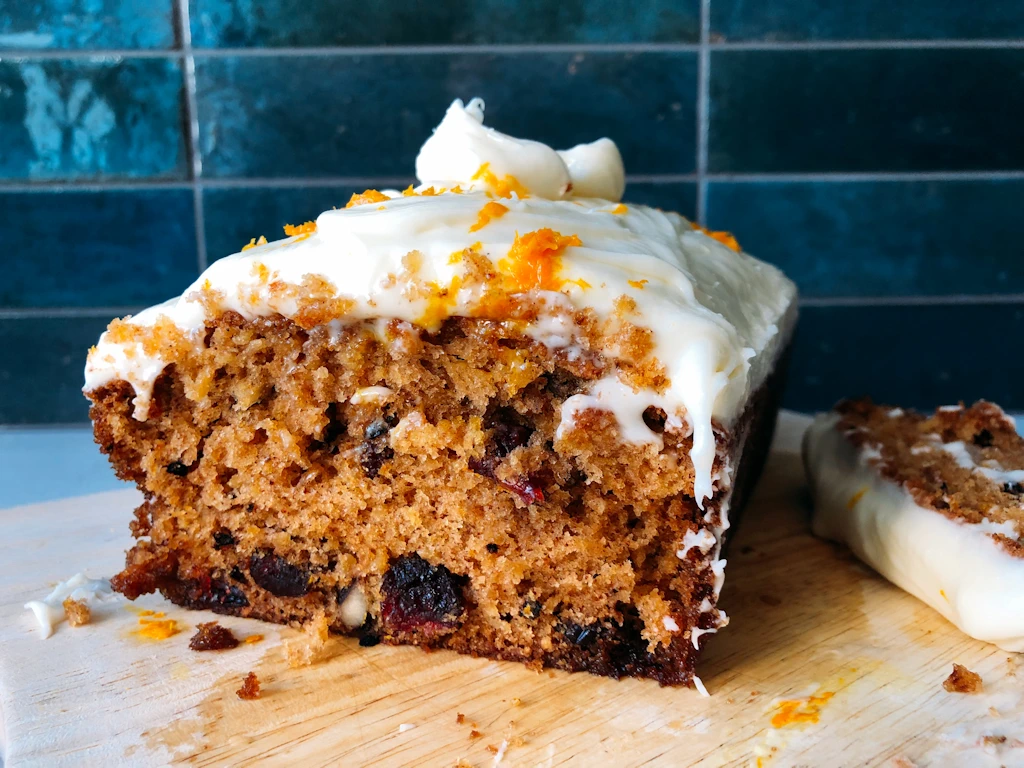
[189,0,700,48]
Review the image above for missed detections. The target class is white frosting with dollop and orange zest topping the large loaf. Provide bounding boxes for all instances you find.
[85,99,796,514]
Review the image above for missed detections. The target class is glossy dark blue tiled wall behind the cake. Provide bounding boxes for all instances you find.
[0,0,1024,424]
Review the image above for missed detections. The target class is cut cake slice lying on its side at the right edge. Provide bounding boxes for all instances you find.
[804,400,1024,652]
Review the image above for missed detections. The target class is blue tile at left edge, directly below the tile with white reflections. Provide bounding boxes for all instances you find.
[0,189,198,307]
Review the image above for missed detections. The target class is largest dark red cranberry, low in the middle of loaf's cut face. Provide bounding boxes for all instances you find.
[381,555,466,637]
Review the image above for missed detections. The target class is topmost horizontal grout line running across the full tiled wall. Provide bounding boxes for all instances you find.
[0,39,1024,59]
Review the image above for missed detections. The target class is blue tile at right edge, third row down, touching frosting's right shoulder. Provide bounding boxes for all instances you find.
[708,180,1024,296]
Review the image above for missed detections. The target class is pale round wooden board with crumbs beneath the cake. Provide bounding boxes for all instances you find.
[0,414,1024,768]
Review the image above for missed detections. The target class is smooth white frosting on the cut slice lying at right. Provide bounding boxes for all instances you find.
[804,414,1024,652]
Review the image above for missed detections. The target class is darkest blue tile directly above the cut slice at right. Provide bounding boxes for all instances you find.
[784,304,1024,411]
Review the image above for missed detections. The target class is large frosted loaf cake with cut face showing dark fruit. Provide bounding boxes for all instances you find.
[85,100,795,684]
